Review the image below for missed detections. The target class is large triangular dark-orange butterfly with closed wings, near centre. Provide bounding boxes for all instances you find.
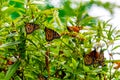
[44,27,61,41]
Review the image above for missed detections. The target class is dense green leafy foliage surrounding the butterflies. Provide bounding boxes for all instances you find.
[0,0,120,80]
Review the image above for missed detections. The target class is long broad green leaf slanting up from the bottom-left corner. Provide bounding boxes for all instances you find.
[5,61,21,80]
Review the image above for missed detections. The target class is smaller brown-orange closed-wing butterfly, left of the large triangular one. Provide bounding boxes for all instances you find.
[25,23,39,34]
